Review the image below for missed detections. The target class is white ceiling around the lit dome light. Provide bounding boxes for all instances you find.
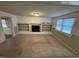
[0,1,79,17]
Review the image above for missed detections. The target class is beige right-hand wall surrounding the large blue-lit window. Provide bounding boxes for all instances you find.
[53,12,79,55]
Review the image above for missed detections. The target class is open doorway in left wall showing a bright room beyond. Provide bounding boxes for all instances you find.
[1,17,12,39]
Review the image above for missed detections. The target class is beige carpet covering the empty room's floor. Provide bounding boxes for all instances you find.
[0,35,76,57]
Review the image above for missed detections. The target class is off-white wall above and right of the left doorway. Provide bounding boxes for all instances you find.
[0,11,17,36]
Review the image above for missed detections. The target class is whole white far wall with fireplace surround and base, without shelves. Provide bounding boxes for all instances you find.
[17,16,52,34]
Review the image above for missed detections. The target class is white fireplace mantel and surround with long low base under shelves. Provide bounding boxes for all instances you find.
[18,23,51,34]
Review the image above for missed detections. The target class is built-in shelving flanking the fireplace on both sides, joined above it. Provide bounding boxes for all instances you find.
[18,23,52,32]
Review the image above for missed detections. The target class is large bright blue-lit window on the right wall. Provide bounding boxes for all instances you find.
[56,18,75,34]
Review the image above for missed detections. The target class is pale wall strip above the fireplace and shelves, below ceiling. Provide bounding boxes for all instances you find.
[17,16,52,23]
